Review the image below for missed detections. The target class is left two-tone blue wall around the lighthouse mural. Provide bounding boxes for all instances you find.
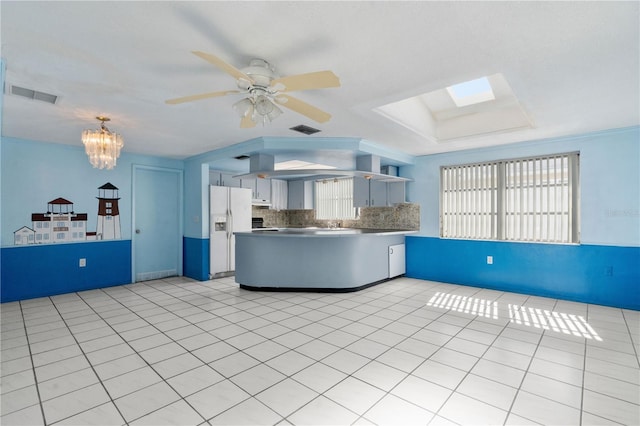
[0,135,184,302]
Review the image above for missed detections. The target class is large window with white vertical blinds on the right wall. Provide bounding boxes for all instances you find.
[440,153,579,243]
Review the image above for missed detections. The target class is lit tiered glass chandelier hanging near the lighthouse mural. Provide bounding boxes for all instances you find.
[82,116,124,170]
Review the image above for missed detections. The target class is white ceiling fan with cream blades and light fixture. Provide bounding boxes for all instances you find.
[165,51,340,128]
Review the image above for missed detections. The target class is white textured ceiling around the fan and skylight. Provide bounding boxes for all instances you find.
[0,0,640,158]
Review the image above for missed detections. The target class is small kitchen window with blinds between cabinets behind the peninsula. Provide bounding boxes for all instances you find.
[315,178,358,220]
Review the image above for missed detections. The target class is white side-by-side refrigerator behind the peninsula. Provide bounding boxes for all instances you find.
[209,186,251,278]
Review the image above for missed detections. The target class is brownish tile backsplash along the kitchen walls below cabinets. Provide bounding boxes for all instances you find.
[252,203,420,231]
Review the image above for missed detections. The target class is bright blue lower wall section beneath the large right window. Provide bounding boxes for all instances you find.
[406,236,640,310]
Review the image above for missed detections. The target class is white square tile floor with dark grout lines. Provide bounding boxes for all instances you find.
[0,278,640,425]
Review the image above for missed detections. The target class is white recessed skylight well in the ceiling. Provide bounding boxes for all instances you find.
[374,73,533,142]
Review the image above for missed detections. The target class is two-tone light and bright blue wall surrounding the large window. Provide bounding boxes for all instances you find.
[402,127,640,309]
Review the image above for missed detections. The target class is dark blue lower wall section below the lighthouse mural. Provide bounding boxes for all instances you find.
[0,240,131,302]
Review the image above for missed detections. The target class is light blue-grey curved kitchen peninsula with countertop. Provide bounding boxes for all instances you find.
[235,228,415,292]
